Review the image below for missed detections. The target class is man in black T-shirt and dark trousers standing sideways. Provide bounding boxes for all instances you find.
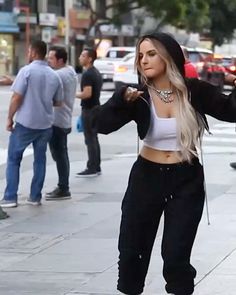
[76,48,102,177]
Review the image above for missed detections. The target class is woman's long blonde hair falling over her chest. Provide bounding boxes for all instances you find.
[135,38,204,162]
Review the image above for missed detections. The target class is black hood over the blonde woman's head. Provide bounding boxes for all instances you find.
[141,32,185,77]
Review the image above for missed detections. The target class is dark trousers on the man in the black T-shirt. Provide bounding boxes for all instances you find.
[82,109,101,172]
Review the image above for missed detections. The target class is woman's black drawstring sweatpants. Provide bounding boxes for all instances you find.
[117,156,205,295]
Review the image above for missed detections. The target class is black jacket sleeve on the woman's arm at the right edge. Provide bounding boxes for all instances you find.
[190,79,236,122]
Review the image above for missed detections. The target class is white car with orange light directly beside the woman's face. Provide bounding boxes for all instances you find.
[113,52,138,89]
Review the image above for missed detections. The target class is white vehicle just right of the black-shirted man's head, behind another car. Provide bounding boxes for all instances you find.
[94,46,135,81]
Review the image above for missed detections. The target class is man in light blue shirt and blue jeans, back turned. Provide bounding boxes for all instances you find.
[0,40,63,208]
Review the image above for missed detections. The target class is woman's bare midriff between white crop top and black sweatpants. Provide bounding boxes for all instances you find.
[140,146,181,164]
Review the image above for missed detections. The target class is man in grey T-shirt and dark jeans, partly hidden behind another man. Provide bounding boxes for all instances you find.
[45,46,77,200]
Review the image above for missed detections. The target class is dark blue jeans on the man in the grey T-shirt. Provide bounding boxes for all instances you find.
[49,126,71,192]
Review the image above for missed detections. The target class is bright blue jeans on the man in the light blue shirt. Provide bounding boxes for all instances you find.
[4,123,52,201]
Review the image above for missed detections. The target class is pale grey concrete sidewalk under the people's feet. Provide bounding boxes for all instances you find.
[0,155,236,295]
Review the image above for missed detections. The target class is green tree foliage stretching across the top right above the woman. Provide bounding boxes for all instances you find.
[82,0,236,45]
